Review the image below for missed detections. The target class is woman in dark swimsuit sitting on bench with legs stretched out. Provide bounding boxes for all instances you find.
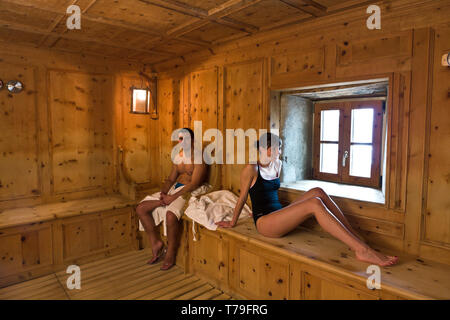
[216,133,398,266]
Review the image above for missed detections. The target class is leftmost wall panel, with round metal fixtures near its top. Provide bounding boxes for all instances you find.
[0,62,41,200]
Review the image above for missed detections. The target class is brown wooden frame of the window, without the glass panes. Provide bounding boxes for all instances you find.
[313,100,384,189]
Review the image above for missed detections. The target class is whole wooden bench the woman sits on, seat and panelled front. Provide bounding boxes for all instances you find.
[180,217,450,300]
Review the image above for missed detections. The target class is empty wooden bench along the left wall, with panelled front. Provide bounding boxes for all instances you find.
[0,195,138,287]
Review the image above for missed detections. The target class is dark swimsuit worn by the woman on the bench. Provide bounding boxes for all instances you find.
[249,164,283,225]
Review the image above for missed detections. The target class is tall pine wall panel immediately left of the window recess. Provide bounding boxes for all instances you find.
[224,60,268,193]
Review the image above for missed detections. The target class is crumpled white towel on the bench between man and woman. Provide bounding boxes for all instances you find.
[184,190,252,237]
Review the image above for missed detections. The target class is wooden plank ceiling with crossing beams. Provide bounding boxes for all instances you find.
[0,0,368,64]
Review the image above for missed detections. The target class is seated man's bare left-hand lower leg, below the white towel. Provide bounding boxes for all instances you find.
[136,200,164,258]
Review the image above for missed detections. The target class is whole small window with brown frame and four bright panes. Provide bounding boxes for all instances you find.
[313,100,384,188]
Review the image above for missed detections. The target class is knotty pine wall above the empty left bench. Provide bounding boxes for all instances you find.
[0,42,162,210]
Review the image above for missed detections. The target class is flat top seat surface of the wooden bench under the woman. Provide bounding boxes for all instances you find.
[199,218,450,299]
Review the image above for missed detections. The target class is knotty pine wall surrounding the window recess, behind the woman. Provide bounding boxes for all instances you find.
[152,0,450,263]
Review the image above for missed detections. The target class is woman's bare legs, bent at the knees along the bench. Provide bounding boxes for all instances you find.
[257,197,398,266]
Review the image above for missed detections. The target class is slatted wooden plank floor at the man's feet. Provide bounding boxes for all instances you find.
[0,250,236,300]
